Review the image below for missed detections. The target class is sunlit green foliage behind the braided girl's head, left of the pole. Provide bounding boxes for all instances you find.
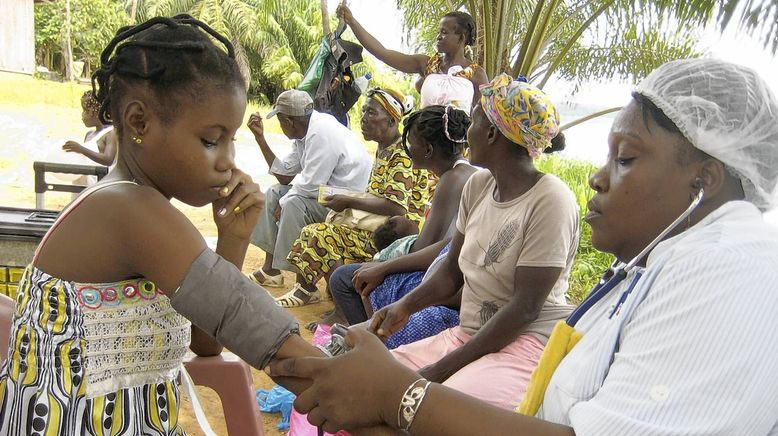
[35,0,323,101]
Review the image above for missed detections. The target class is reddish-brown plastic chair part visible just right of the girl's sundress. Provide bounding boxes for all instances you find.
[184,351,264,436]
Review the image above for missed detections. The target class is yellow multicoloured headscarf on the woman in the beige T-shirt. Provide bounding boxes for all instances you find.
[480,73,559,159]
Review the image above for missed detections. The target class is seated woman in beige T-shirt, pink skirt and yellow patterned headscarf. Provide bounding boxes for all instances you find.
[304,75,578,409]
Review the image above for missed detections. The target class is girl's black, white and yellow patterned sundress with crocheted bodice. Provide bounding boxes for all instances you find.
[0,180,191,435]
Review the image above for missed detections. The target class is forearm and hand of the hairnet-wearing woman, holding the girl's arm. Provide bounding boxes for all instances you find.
[270,328,575,436]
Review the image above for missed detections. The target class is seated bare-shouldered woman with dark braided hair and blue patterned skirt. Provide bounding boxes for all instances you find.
[329,105,476,338]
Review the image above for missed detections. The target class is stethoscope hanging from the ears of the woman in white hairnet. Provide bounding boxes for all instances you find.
[566,188,705,327]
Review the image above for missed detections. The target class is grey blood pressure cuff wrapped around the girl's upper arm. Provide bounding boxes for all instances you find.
[170,248,300,369]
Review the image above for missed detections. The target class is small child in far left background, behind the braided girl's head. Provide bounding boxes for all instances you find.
[62,91,117,166]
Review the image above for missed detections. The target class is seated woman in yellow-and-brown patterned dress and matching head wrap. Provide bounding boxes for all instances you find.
[276,88,428,307]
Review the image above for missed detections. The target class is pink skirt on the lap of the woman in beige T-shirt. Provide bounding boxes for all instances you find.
[392,327,543,410]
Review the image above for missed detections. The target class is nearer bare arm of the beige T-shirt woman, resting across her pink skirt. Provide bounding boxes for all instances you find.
[419,267,562,383]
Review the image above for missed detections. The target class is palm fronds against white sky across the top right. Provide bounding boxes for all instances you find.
[397,0,778,87]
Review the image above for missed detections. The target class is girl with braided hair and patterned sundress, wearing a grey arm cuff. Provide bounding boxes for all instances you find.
[0,15,318,435]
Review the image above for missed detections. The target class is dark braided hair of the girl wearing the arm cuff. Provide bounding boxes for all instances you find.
[92,14,246,131]
